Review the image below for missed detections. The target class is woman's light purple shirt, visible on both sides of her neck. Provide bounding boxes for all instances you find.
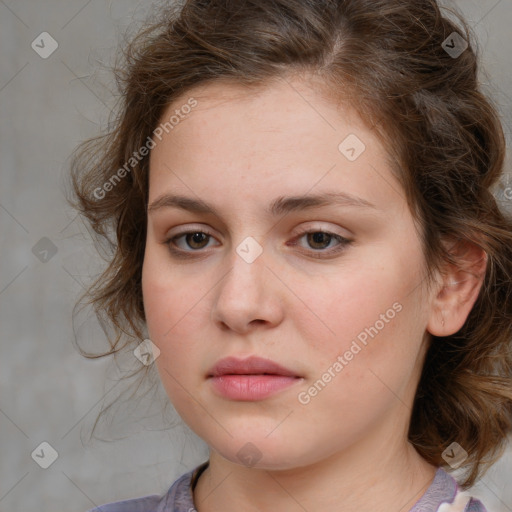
[87,461,487,512]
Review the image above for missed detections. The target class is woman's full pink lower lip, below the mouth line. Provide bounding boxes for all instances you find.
[210,375,302,400]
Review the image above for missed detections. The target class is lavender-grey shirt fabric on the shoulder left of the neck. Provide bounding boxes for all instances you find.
[87,462,208,512]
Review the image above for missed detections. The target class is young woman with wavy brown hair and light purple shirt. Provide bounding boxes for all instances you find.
[72,0,512,512]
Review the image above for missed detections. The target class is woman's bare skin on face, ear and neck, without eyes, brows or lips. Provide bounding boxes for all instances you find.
[142,74,482,512]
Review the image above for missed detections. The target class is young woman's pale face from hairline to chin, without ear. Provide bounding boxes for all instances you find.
[142,75,436,469]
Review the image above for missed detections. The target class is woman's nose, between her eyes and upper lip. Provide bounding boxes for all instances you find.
[211,241,284,334]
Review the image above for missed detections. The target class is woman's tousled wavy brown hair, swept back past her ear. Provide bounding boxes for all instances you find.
[71,0,512,488]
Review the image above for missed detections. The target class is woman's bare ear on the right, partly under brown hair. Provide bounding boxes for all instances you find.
[427,240,487,336]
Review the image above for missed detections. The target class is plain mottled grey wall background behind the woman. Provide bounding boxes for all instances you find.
[0,0,512,512]
